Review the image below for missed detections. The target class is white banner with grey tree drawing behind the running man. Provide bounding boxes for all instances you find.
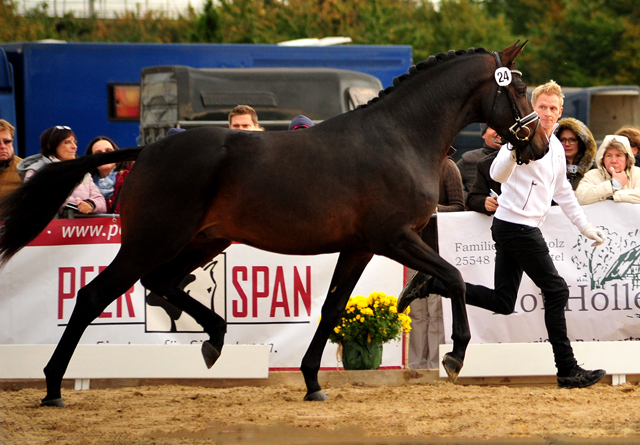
[438,201,640,343]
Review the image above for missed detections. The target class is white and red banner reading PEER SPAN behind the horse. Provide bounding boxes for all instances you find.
[0,218,404,369]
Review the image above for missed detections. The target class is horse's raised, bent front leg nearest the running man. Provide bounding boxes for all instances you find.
[376,231,471,382]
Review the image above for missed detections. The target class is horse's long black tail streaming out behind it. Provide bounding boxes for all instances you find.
[0,147,144,266]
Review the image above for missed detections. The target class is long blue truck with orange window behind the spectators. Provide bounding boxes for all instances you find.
[0,42,412,157]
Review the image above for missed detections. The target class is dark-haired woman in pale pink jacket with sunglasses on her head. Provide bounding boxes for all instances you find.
[18,125,107,214]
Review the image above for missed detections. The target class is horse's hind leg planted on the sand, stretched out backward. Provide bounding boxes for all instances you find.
[40,254,140,407]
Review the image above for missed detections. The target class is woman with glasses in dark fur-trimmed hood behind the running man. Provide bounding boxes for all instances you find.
[553,117,596,190]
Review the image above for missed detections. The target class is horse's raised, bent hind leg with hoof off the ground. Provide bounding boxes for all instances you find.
[141,234,231,368]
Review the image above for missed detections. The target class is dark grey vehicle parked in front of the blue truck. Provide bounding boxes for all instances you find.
[140,65,382,144]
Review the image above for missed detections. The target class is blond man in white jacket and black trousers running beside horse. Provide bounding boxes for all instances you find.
[398,81,606,388]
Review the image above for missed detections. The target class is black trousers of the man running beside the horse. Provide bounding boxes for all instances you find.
[433,218,577,374]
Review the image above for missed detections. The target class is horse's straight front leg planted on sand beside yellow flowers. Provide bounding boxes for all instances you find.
[300,252,373,401]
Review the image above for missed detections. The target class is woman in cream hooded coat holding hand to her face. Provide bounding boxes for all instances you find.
[576,135,640,205]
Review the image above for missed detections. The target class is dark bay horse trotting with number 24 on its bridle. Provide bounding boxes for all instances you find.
[0,42,548,406]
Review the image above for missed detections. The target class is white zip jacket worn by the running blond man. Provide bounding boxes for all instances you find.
[490,128,588,230]
